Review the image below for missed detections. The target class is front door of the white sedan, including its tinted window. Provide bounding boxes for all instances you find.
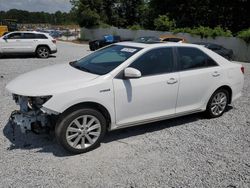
[113,47,179,126]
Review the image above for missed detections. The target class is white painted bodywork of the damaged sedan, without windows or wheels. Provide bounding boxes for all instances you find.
[7,42,244,130]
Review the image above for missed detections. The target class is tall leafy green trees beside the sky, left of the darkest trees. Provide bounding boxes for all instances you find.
[71,0,144,27]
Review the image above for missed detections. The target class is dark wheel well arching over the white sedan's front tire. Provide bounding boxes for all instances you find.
[63,102,111,128]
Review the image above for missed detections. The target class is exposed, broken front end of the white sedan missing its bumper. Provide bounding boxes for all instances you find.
[10,94,56,133]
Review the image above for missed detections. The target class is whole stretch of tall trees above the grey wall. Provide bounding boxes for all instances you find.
[71,0,250,33]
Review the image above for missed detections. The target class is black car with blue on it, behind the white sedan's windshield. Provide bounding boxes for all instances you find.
[89,35,121,51]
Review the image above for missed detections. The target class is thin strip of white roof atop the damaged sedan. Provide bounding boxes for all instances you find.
[115,42,201,48]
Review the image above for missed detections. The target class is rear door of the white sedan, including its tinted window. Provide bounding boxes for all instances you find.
[176,47,223,113]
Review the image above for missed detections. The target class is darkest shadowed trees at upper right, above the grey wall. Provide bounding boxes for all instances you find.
[149,0,250,33]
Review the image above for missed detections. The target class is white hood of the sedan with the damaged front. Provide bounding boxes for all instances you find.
[6,63,99,96]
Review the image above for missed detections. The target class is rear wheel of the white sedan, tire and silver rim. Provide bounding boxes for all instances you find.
[206,89,229,118]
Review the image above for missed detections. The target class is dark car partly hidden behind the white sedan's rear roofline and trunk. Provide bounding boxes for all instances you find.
[194,42,233,60]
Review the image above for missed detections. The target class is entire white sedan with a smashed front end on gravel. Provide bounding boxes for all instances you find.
[7,42,244,153]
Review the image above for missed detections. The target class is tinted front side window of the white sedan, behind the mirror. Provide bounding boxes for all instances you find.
[129,47,174,76]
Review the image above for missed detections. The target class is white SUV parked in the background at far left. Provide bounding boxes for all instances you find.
[0,31,57,58]
